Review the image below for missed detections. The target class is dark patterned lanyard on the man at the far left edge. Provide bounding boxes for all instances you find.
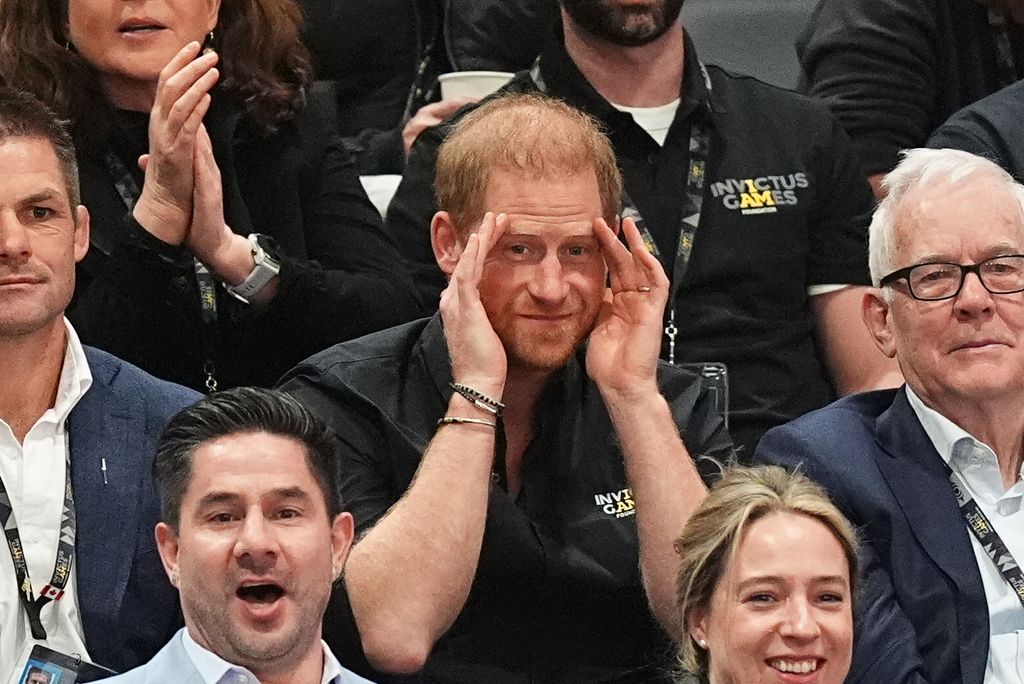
[0,452,75,641]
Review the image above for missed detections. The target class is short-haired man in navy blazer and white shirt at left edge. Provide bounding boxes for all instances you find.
[0,88,198,682]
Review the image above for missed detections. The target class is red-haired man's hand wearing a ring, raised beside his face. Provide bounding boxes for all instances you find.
[587,218,669,396]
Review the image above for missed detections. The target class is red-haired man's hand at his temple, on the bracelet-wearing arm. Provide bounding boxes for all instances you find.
[439,212,508,398]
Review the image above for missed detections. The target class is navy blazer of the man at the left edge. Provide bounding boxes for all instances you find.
[68,347,199,671]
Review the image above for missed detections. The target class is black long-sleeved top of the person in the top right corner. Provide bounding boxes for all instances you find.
[797,0,1024,174]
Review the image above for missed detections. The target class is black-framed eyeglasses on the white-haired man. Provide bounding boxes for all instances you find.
[879,254,1024,302]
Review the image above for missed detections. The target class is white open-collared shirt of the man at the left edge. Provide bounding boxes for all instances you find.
[0,319,92,684]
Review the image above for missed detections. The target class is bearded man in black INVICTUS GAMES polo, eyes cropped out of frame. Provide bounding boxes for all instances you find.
[386,0,901,459]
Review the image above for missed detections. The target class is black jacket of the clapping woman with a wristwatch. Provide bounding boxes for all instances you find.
[69,83,421,389]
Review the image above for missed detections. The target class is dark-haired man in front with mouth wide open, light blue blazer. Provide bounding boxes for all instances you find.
[106,387,376,684]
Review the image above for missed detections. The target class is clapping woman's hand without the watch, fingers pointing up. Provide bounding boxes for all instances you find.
[133,42,220,245]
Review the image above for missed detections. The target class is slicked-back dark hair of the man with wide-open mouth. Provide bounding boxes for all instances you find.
[153,387,344,531]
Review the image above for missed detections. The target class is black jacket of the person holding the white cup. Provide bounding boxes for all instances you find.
[299,0,558,174]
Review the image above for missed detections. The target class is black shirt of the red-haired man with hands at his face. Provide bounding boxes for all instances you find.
[283,316,729,684]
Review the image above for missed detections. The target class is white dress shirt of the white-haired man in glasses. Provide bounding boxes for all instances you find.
[906,386,1024,684]
